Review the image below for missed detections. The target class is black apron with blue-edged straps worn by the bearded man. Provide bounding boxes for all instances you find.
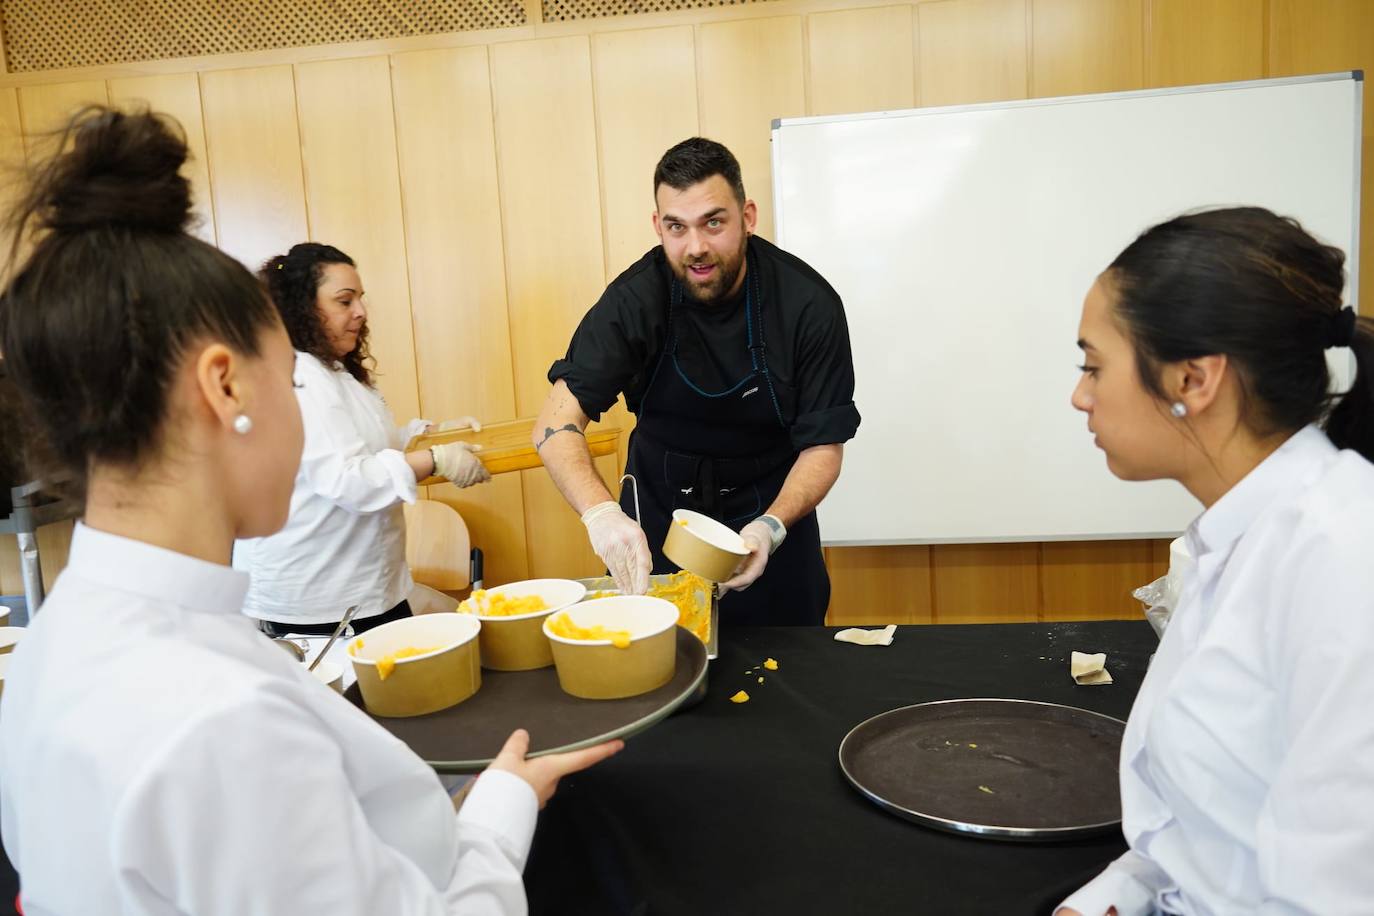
[620,251,830,626]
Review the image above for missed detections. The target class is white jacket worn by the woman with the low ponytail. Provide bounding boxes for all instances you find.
[1063,427,1374,916]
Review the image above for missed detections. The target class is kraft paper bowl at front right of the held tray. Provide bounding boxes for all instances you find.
[544,595,677,700]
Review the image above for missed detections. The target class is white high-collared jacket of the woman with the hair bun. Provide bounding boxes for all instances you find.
[0,525,537,916]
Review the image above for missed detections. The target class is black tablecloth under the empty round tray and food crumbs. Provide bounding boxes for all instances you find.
[525,621,1157,916]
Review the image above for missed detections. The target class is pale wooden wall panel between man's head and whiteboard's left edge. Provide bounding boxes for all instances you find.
[697,16,807,239]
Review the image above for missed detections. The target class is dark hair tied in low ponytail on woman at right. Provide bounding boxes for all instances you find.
[1107,207,1374,460]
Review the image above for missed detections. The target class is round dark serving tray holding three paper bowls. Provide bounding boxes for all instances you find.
[344,626,706,773]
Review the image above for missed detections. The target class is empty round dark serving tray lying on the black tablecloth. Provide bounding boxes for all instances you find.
[840,699,1125,842]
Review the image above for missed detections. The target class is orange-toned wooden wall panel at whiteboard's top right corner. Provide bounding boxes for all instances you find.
[1270,0,1374,314]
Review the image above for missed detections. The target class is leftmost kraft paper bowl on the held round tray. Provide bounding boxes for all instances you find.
[348,614,482,718]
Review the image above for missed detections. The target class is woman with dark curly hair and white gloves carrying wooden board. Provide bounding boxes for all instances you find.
[234,242,491,636]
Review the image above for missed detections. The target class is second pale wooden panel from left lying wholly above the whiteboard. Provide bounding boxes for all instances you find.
[916,0,1028,106]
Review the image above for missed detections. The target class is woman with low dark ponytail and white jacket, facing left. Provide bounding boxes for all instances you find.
[1058,207,1374,916]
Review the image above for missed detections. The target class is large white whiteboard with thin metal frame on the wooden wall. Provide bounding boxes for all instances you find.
[772,73,1362,544]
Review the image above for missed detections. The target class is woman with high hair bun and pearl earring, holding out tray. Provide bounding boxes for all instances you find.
[0,108,621,916]
